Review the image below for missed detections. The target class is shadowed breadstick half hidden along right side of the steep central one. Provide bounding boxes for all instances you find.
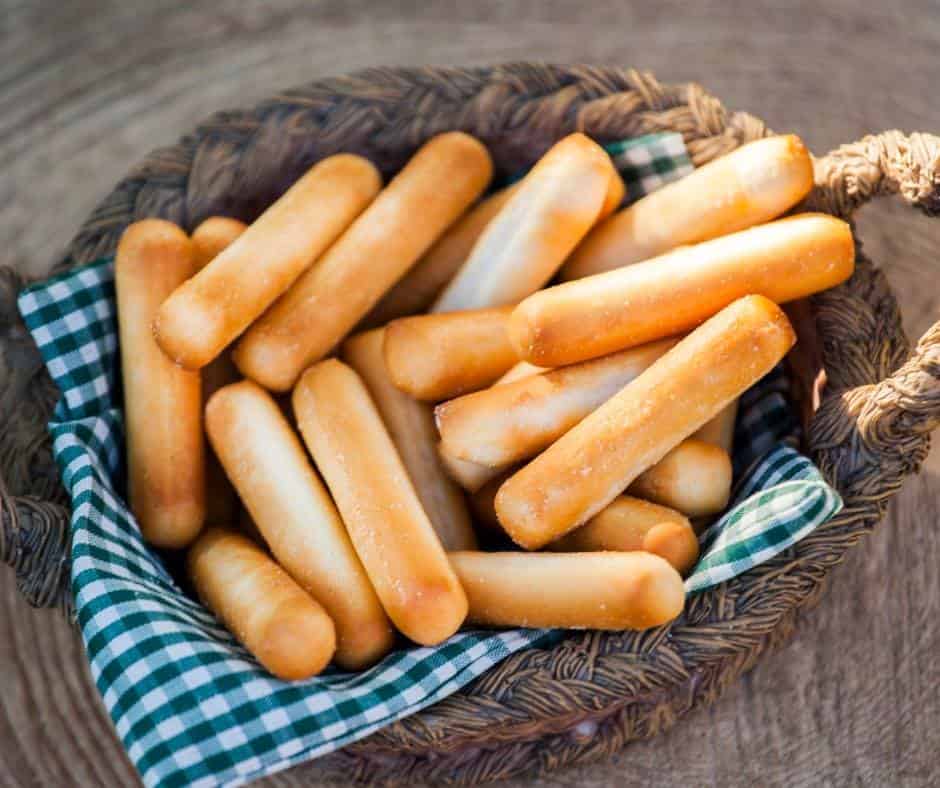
[343,328,476,550]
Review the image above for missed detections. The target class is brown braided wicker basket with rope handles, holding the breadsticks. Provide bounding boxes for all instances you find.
[0,63,940,783]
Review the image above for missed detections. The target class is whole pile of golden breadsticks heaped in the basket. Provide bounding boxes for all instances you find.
[116,127,854,679]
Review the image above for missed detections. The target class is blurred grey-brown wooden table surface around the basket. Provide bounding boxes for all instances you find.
[0,0,940,786]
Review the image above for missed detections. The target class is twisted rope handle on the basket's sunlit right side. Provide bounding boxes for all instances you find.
[806,130,940,496]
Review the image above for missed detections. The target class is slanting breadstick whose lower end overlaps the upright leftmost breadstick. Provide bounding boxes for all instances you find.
[154,154,382,369]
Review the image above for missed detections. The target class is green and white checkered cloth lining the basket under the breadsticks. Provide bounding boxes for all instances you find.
[19,135,840,786]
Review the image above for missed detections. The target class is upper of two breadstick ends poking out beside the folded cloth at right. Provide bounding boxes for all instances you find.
[627,438,731,517]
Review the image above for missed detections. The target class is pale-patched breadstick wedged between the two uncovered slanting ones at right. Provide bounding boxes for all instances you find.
[434,338,679,468]
